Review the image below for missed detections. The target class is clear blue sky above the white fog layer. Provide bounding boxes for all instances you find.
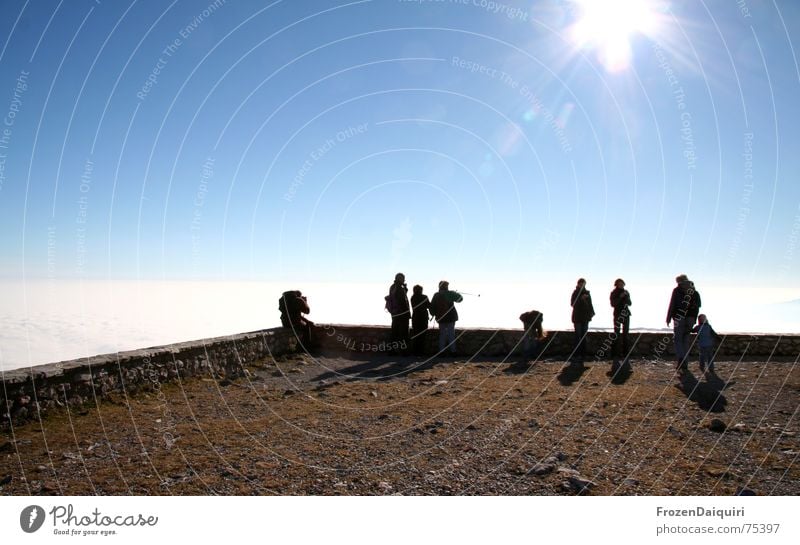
[0,0,800,291]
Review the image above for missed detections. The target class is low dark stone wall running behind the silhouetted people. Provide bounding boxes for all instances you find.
[0,324,800,426]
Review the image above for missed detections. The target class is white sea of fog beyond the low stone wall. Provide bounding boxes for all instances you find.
[0,280,800,370]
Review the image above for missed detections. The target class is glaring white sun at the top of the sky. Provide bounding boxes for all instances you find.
[570,0,660,72]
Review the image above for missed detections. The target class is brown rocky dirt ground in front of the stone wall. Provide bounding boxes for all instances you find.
[0,356,800,495]
